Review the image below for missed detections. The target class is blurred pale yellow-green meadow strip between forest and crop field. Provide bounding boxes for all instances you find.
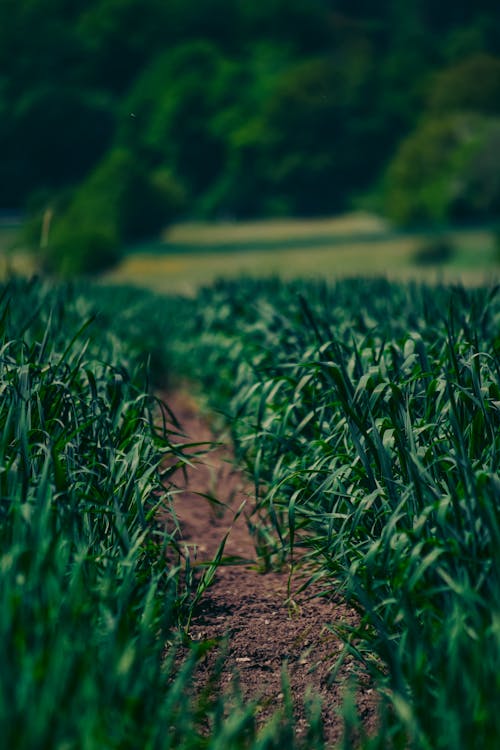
[0,213,500,294]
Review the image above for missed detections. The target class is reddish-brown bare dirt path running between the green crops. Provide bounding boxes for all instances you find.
[163,389,375,746]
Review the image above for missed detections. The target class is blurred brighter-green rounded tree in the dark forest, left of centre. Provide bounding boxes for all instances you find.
[121,42,240,199]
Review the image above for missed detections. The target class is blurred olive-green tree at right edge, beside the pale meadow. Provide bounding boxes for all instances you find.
[386,54,500,224]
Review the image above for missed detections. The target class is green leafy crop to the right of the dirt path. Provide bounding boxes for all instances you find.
[172,280,500,750]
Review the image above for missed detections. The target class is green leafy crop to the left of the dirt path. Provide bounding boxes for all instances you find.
[0,280,328,750]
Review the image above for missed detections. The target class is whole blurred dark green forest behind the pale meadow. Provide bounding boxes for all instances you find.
[0,0,500,270]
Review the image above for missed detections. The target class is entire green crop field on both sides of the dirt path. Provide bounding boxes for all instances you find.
[0,264,500,750]
